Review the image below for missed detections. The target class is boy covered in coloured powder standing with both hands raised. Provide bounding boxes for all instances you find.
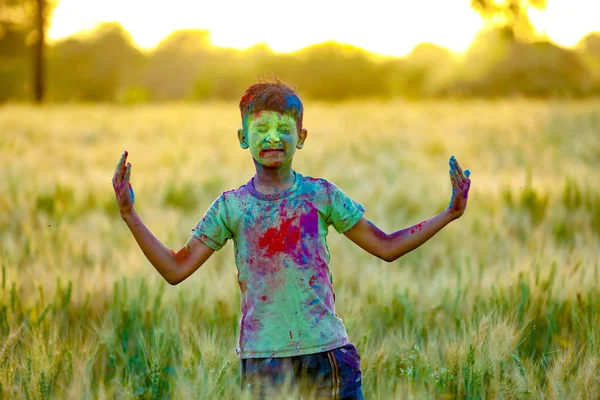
[113,79,471,399]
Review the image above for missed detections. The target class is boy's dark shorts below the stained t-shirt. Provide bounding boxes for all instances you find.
[241,343,364,400]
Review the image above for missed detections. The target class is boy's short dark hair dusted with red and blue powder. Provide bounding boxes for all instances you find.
[240,75,304,132]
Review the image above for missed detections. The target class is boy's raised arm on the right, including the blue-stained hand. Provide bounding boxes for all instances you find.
[344,156,471,262]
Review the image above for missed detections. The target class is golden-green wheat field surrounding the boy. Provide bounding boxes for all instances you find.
[0,99,600,399]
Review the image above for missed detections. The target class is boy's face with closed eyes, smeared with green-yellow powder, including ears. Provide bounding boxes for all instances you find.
[238,111,307,168]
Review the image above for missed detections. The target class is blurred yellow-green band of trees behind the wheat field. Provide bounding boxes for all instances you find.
[0,0,600,104]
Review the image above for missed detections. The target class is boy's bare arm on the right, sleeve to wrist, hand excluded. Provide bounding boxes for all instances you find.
[344,209,455,262]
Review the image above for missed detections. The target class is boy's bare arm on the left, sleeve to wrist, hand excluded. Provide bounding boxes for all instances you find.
[122,210,215,285]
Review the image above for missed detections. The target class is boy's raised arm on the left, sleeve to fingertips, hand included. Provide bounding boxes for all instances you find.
[112,151,214,285]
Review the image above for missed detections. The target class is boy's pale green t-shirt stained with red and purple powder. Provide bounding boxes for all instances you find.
[192,172,365,358]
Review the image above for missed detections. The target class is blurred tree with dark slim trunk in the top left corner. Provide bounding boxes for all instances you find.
[0,0,56,103]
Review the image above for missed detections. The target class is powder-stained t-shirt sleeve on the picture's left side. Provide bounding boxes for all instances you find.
[192,194,233,251]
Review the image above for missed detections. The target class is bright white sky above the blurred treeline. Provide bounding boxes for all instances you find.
[49,0,600,56]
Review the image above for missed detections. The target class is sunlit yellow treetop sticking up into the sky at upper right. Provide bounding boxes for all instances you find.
[471,0,547,41]
